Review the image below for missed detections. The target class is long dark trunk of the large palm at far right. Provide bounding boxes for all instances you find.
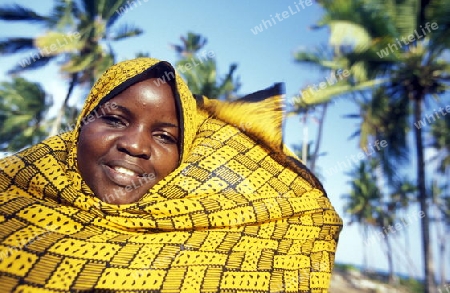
[413,95,436,293]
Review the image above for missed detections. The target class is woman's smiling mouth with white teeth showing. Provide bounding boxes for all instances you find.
[102,161,146,186]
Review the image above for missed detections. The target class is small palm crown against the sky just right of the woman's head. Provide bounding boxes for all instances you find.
[172,32,240,100]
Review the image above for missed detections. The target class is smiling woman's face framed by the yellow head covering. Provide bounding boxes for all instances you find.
[77,79,181,204]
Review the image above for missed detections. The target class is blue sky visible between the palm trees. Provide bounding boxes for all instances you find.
[0,0,442,274]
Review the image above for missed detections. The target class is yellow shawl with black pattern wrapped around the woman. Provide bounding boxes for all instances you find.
[0,58,342,293]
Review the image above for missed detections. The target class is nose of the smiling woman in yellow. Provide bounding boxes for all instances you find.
[117,129,151,159]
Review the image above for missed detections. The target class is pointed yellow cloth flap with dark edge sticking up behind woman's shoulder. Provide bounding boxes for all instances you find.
[202,83,284,151]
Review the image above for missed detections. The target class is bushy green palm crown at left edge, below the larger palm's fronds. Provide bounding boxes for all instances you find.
[0,77,52,152]
